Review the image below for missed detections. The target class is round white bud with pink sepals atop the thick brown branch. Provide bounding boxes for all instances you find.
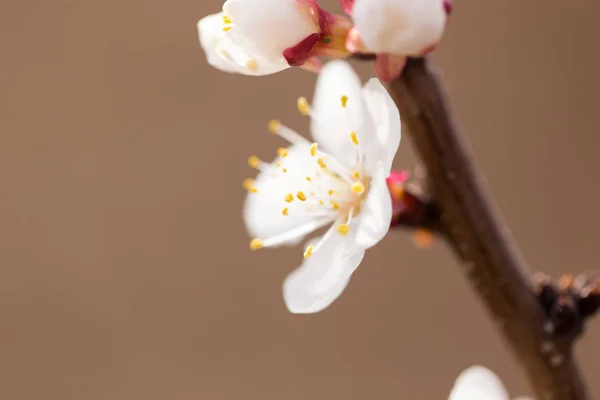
[340,0,451,81]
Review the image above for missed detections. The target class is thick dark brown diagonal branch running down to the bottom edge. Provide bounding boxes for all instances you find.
[389,58,589,400]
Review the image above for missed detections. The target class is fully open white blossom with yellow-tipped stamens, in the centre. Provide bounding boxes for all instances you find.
[244,61,400,313]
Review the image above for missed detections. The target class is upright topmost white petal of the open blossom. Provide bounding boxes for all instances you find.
[310,60,378,166]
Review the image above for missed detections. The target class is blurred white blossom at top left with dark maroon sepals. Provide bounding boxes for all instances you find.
[198,0,350,75]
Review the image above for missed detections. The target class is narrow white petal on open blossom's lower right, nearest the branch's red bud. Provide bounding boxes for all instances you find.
[356,162,392,248]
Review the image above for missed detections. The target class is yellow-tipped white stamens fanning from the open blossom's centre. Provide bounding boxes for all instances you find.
[243,96,370,258]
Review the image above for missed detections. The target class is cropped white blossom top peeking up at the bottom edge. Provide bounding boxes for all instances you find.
[448,365,532,400]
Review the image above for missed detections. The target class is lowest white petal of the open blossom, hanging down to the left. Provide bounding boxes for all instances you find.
[283,226,365,314]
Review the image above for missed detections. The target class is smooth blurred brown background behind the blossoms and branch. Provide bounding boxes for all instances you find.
[0,0,600,400]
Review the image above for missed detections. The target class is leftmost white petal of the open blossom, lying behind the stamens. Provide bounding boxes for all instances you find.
[243,144,330,245]
